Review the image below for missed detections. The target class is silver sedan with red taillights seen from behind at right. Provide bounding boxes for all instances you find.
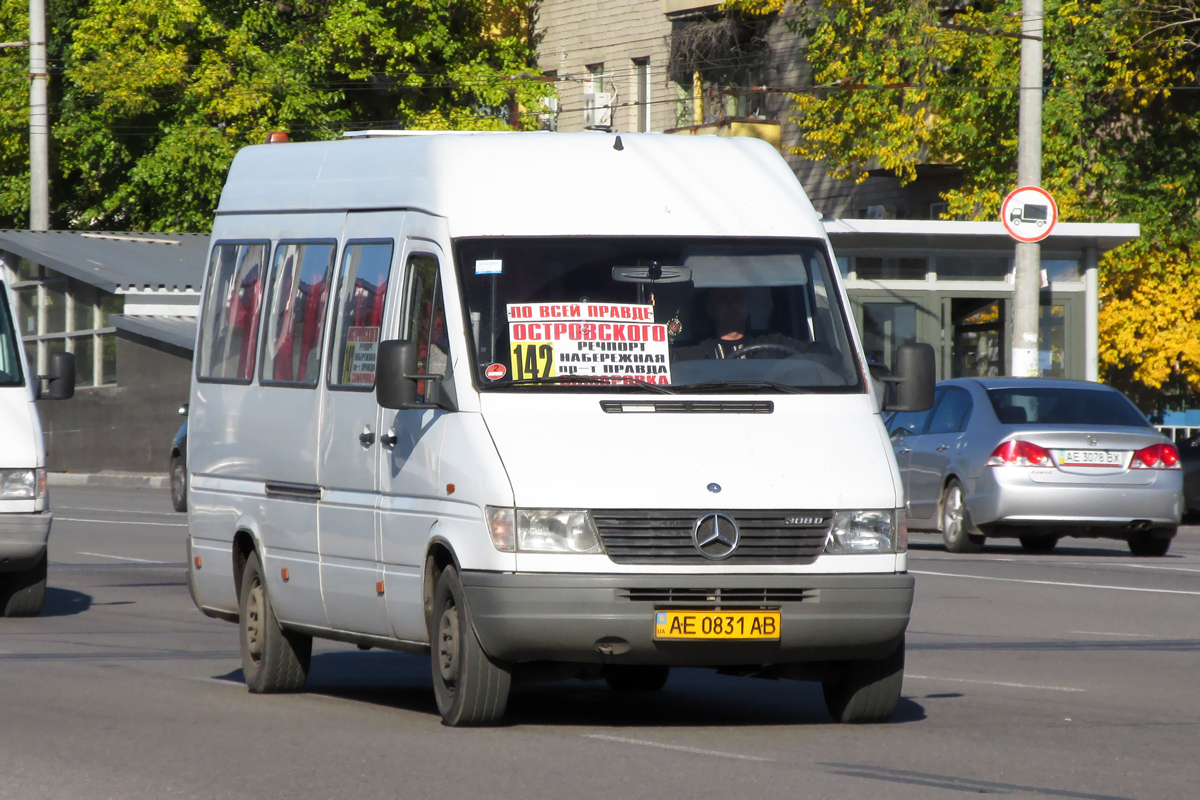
[887,378,1183,555]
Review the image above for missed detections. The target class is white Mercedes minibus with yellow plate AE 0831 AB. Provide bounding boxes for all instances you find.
[187,133,934,724]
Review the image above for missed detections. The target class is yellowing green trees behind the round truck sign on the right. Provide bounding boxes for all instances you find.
[727,0,1200,408]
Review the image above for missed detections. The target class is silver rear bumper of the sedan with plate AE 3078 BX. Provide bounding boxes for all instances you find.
[966,468,1183,534]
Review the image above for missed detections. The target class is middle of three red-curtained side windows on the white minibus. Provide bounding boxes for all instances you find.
[259,242,334,386]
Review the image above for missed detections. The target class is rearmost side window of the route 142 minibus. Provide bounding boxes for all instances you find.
[197,243,266,383]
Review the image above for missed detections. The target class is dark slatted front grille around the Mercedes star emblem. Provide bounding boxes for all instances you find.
[592,509,833,564]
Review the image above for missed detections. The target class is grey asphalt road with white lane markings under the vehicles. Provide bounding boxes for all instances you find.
[0,487,1200,800]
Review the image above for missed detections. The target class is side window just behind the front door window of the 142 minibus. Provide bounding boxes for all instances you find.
[329,240,392,390]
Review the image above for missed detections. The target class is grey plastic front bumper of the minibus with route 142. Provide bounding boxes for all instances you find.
[462,571,916,667]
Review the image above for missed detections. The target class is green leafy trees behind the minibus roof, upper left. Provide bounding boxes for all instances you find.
[0,0,552,230]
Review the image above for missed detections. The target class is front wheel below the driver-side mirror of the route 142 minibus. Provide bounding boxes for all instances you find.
[430,566,512,727]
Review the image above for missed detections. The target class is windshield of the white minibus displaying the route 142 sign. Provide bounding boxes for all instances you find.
[455,236,863,393]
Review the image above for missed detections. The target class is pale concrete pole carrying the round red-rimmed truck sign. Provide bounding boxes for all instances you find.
[1009,0,1044,378]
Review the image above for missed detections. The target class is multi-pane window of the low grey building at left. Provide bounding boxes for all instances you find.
[2,253,122,389]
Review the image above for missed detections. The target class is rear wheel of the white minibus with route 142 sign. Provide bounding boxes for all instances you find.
[238,553,312,694]
